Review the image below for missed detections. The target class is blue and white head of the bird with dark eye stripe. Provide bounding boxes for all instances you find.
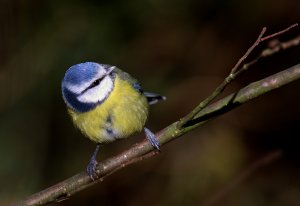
[62,62,116,112]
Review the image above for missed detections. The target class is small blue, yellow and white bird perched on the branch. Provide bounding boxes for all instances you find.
[62,62,166,180]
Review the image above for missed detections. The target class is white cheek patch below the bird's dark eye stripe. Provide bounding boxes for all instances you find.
[77,76,113,103]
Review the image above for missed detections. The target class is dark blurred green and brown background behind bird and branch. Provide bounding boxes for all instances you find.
[0,0,300,206]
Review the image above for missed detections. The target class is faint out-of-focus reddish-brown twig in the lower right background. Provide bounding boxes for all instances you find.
[202,150,282,206]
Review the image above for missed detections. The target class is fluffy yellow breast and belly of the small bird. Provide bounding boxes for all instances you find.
[69,75,149,143]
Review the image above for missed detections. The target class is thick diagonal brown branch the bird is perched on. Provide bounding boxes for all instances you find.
[15,64,300,206]
